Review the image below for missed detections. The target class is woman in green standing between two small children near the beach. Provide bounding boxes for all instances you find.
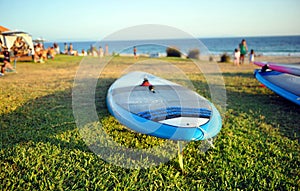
[233,39,255,66]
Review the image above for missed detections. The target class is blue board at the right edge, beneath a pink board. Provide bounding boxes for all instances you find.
[254,69,300,105]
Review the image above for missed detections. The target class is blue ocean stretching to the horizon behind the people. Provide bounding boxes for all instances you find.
[44,36,300,56]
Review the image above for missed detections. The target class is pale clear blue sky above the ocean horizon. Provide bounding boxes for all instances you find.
[0,0,300,41]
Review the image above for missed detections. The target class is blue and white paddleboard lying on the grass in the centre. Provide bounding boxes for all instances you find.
[107,71,222,141]
